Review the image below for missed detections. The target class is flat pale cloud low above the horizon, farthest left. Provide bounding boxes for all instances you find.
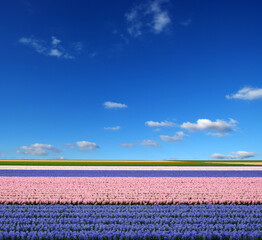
[16,143,61,156]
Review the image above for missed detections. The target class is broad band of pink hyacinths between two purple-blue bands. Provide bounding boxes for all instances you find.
[0,177,262,204]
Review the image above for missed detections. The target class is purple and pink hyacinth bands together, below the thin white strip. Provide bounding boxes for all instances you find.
[0,170,262,240]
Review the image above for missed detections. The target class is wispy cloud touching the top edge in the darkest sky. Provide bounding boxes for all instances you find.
[125,0,171,37]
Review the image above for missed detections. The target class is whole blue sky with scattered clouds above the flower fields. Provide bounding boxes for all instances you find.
[0,0,262,160]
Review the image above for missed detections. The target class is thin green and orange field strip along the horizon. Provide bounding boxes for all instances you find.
[0,160,262,167]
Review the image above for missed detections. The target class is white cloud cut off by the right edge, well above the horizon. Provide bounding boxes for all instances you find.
[226,87,262,100]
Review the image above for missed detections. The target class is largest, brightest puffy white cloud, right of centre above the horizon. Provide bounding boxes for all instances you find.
[180,118,237,136]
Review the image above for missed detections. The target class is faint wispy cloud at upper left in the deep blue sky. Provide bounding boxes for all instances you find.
[19,36,74,59]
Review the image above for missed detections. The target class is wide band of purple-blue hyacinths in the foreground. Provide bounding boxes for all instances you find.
[0,205,262,239]
